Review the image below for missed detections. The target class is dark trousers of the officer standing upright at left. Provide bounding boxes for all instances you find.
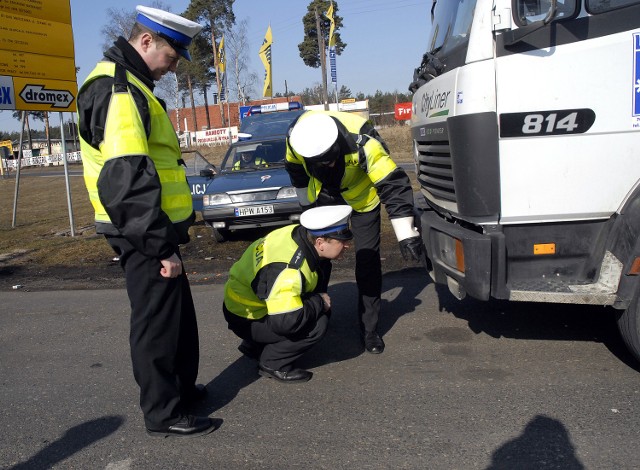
[106,236,199,429]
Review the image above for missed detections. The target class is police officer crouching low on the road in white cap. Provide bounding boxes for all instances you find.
[223,205,353,383]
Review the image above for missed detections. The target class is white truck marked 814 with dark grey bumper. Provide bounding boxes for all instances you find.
[410,0,640,360]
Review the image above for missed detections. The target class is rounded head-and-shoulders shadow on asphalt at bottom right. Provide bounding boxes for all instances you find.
[486,415,584,470]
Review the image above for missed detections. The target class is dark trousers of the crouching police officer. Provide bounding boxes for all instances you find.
[222,305,329,372]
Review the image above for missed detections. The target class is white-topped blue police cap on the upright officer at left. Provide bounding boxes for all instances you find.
[136,5,202,61]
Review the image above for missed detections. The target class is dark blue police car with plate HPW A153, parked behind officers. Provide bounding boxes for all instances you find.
[189,102,304,242]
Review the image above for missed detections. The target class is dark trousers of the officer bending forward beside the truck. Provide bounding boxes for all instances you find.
[351,204,382,332]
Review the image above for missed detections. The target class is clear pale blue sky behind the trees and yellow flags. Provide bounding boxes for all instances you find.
[0,0,430,130]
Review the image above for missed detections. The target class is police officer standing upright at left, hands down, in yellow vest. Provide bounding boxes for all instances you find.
[78,6,215,436]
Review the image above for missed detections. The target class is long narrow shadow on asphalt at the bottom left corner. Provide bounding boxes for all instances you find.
[10,416,124,470]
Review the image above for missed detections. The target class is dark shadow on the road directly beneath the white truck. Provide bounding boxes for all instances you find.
[436,285,640,371]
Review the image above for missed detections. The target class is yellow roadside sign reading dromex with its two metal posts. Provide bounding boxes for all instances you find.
[0,0,78,236]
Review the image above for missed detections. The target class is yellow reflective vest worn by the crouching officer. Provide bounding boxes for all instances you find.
[224,225,318,320]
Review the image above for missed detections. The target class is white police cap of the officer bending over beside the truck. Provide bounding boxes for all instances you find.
[289,111,338,159]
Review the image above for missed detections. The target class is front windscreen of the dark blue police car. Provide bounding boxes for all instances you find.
[222,140,286,171]
